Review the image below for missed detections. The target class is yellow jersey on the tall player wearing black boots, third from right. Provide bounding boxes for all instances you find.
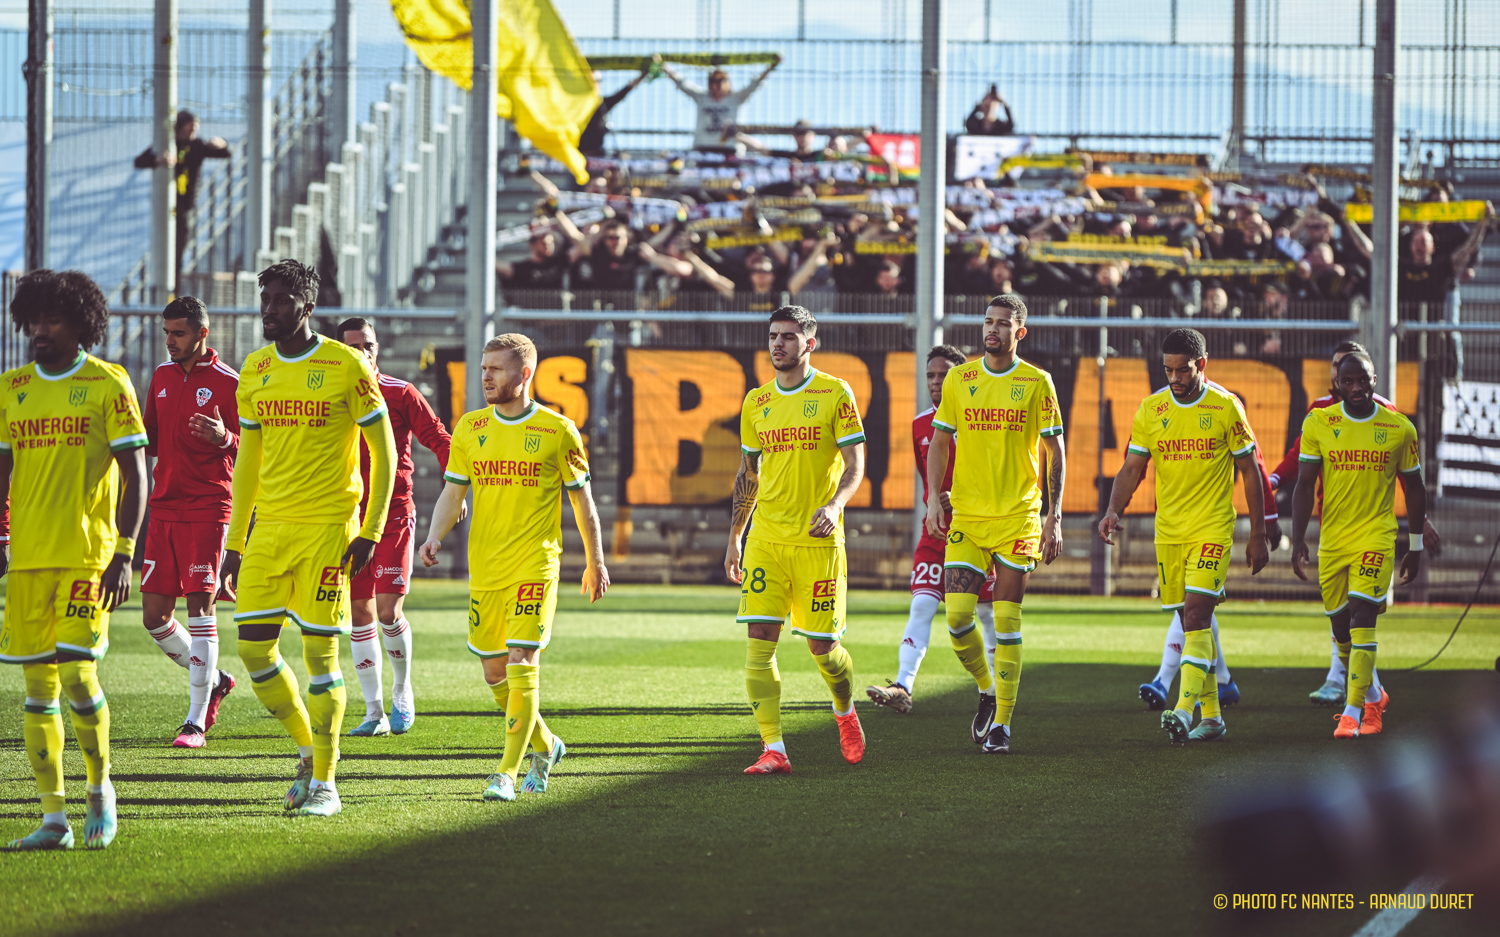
[933,358,1062,523]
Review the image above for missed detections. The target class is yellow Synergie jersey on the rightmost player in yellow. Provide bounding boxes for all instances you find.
[1298,403,1422,553]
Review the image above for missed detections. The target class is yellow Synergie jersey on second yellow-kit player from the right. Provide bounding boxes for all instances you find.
[1130,381,1256,543]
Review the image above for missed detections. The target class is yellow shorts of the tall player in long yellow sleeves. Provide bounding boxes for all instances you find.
[234,520,360,634]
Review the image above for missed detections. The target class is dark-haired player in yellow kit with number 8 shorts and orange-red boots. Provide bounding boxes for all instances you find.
[725,306,864,775]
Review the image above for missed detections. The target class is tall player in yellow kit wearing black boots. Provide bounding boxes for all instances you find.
[926,292,1065,754]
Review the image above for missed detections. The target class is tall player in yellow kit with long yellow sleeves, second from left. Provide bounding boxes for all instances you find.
[221,261,396,817]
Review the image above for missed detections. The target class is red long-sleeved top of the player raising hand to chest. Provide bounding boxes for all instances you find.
[143,348,240,523]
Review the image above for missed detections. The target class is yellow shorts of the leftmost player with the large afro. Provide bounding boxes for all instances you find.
[0,570,110,664]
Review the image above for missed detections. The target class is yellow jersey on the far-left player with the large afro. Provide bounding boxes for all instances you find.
[0,352,146,570]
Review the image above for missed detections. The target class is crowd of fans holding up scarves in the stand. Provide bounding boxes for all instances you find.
[498,73,1494,318]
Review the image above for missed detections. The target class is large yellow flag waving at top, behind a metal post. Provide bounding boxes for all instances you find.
[390,0,600,183]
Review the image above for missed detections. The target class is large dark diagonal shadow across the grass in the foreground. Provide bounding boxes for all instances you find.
[49,664,1488,937]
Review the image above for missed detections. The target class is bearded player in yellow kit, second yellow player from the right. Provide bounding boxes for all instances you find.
[1098,328,1268,742]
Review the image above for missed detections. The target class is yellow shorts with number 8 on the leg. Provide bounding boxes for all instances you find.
[735,538,849,642]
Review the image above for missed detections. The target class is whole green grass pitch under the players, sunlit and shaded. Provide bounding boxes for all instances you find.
[0,580,1500,937]
